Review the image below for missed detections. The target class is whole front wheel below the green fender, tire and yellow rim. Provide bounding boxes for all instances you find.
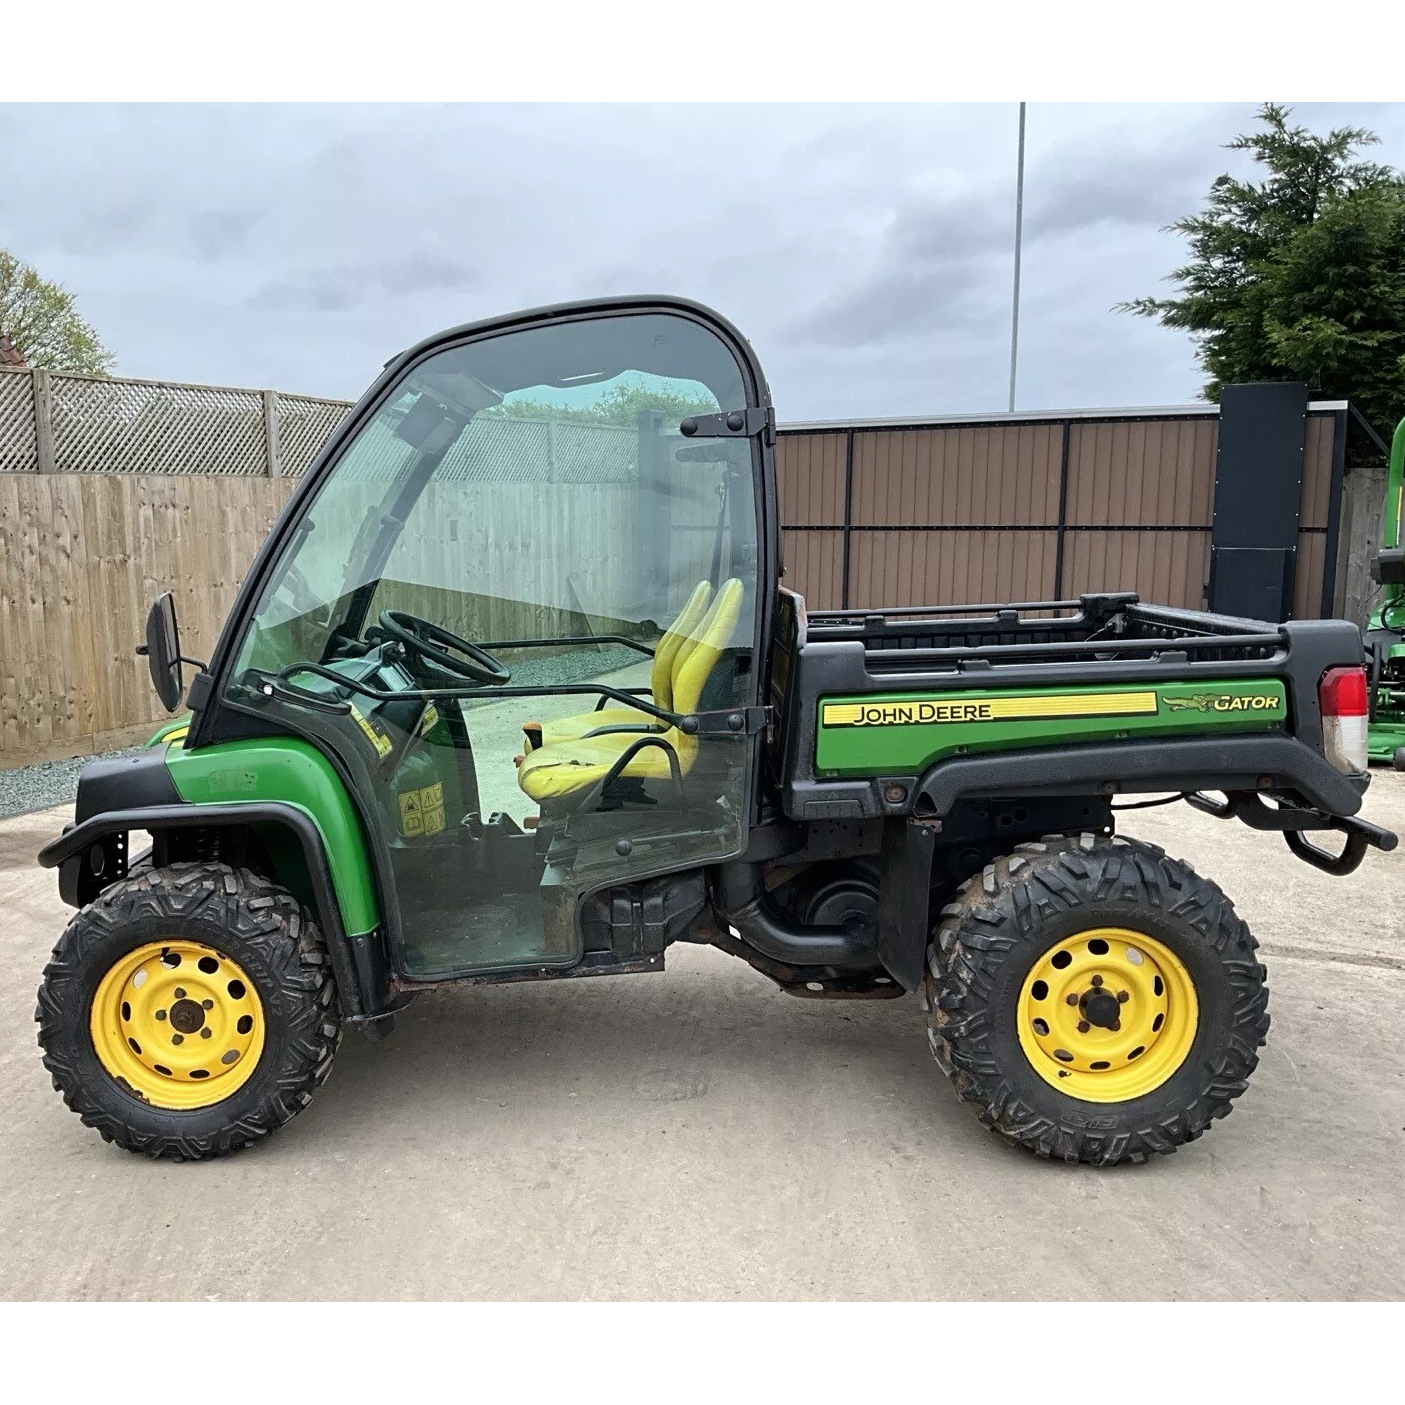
[35,863,341,1161]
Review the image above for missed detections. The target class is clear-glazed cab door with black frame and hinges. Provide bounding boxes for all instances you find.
[221,303,774,979]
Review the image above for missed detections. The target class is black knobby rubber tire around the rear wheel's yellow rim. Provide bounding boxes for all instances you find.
[923,835,1269,1166]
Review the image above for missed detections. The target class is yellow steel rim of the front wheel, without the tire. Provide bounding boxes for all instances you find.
[89,941,264,1110]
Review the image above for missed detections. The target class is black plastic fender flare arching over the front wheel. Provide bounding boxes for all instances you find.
[39,801,373,1020]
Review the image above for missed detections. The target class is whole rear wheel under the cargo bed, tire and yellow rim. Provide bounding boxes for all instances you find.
[924,835,1269,1166]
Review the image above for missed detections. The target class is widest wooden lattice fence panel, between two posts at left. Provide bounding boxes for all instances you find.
[51,375,267,473]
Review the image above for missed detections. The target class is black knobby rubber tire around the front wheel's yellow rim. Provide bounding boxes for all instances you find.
[35,863,341,1161]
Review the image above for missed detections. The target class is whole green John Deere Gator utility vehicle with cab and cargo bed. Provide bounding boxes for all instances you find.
[38,298,1395,1165]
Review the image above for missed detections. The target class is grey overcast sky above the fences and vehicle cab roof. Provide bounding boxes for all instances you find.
[0,103,1405,420]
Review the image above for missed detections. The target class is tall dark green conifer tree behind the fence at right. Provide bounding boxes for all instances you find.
[1118,103,1405,437]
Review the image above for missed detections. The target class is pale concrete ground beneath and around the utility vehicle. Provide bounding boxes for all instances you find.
[0,773,1405,1301]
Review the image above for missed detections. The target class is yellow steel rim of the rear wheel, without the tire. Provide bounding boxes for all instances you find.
[1016,927,1200,1103]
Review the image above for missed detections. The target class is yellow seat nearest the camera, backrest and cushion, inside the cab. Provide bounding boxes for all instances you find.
[517,579,743,802]
